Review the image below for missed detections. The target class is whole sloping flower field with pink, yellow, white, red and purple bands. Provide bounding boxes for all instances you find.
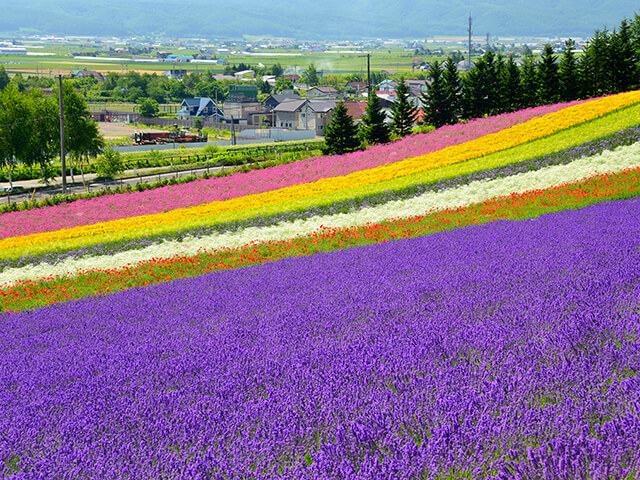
[0,92,640,479]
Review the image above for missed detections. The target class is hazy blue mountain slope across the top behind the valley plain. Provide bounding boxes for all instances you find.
[0,0,639,40]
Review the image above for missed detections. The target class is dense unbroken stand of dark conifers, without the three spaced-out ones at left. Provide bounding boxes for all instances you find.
[421,14,640,127]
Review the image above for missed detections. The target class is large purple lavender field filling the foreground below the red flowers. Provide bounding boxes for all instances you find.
[0,198,640,479]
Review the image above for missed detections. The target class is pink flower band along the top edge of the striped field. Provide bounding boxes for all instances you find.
[0,102,579,238]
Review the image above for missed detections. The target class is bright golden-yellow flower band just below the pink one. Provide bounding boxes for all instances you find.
[0,91,640,256]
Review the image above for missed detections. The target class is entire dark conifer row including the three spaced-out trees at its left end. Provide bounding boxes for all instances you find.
[325,14,640,154]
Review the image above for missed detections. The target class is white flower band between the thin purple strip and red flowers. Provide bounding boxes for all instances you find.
[0,142,640,288]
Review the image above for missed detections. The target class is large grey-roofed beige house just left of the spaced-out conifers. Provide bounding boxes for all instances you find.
[273,99,337,135]
